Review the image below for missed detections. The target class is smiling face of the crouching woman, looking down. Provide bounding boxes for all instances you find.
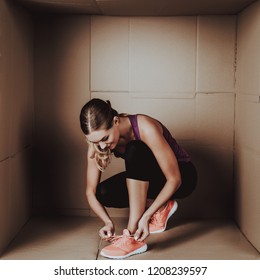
[86,117,119,150]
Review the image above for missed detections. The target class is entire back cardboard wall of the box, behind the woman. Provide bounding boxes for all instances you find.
[34,16,236,218]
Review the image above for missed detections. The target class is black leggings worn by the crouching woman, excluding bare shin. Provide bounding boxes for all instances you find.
[96,140,197,208]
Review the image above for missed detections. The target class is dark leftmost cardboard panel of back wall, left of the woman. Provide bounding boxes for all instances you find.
[34,15,90,215]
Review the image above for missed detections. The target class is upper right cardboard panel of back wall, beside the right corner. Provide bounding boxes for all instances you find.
[196,16,236,92]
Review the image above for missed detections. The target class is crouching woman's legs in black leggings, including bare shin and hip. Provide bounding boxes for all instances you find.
[97,141,197,231]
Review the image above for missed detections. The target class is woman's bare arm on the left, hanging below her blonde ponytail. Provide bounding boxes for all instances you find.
[86,147,114,239]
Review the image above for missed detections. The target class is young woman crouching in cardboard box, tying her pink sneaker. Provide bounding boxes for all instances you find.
[80,99,197,258]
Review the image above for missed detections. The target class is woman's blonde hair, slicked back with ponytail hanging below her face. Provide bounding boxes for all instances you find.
[80,98,118,172]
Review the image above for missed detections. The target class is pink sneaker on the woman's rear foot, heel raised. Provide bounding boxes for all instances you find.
[149,200,178,233]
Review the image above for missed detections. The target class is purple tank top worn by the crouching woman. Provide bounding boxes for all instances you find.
[128,115,191,161]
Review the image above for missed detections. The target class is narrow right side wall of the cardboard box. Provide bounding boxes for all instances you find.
[235,1,260,251]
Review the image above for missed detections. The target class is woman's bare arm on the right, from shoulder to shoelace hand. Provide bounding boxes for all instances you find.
[134,115,181,240]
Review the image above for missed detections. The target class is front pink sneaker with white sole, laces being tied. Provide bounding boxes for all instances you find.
[100,229,147,259]
